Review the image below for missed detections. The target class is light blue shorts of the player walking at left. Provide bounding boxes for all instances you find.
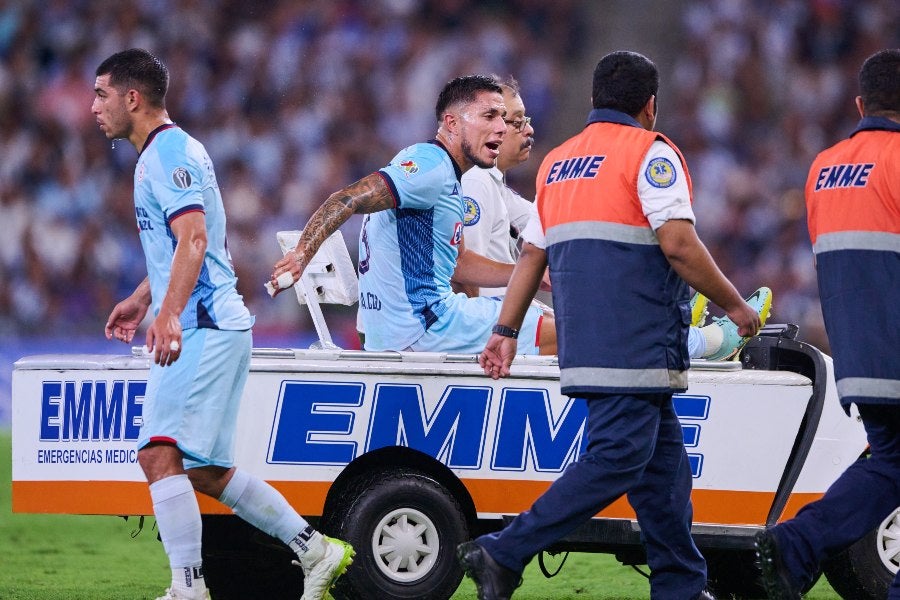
[138,328,253,469]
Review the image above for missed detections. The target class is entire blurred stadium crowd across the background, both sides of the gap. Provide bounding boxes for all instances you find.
[0,0,900,347]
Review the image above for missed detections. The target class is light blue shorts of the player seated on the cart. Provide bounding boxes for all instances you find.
[409,294,544,354]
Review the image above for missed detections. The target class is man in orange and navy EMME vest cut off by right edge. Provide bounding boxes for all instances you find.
[756,48,900,600]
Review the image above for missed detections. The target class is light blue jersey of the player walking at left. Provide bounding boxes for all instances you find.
[134,124,253,331]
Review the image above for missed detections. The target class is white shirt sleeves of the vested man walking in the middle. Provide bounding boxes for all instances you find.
[520,140,696,249]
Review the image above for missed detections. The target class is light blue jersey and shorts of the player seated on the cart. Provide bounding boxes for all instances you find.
[359,141,541,354]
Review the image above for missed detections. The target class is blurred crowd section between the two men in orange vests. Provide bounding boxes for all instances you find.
[660,0,900,350]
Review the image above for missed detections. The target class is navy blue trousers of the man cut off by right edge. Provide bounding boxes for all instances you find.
[772,404,900,600]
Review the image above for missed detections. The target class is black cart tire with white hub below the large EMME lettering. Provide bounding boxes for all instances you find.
[323,472,469,600]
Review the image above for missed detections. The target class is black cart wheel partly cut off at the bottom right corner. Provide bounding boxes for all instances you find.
[823,508,900,600]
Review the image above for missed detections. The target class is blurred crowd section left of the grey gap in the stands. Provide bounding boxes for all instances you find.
[0,0,583,346]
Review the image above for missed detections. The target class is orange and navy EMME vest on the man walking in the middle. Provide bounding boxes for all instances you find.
[537,116,690,393]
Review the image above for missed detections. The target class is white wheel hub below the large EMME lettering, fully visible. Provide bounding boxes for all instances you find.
[372,508,440,583]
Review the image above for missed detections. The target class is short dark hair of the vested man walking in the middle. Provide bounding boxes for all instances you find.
[591,50,659,117]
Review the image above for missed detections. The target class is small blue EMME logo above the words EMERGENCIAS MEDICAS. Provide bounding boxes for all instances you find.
[40,380,147,442]
